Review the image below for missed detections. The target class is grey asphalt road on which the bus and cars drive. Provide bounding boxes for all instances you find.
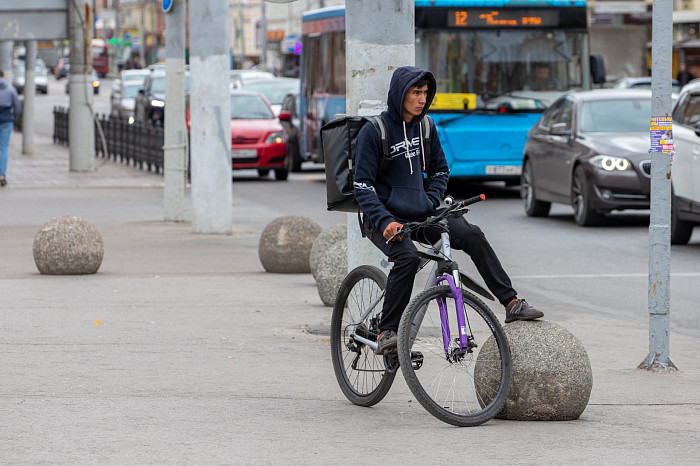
[24,72,700,335]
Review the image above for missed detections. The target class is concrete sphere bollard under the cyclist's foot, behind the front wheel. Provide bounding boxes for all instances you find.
[474,320,593,421]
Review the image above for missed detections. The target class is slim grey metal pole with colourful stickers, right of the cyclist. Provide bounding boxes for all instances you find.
[639,0,676,371]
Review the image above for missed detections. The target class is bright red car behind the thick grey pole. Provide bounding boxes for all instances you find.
[187,91,289,180]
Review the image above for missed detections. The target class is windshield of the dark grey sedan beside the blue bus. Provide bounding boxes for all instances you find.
[580,99,651,133]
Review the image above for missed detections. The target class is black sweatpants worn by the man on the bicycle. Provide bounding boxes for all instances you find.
[363,216,517,330]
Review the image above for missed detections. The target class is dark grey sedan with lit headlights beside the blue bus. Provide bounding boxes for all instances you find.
[521,89,651,226]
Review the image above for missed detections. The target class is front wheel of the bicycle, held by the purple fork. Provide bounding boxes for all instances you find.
[398,285,512,427]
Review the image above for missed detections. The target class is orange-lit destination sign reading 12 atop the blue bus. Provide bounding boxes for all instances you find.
[447,8,559,28]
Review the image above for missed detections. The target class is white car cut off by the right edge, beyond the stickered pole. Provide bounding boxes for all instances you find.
[671,80,700,244]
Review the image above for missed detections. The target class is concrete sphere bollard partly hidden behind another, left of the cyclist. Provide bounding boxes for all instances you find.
[258,215,321,273]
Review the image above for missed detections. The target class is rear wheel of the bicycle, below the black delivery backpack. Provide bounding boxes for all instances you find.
[331,265,396,406]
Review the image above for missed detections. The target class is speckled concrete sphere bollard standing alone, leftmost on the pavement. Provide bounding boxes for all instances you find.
[33,215,104,275]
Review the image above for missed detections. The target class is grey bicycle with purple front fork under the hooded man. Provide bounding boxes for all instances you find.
[331,194,512,427]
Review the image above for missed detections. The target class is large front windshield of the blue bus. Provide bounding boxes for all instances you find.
[416,29,586,109]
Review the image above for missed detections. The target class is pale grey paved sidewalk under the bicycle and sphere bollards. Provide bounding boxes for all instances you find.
[0,133,700,465]
